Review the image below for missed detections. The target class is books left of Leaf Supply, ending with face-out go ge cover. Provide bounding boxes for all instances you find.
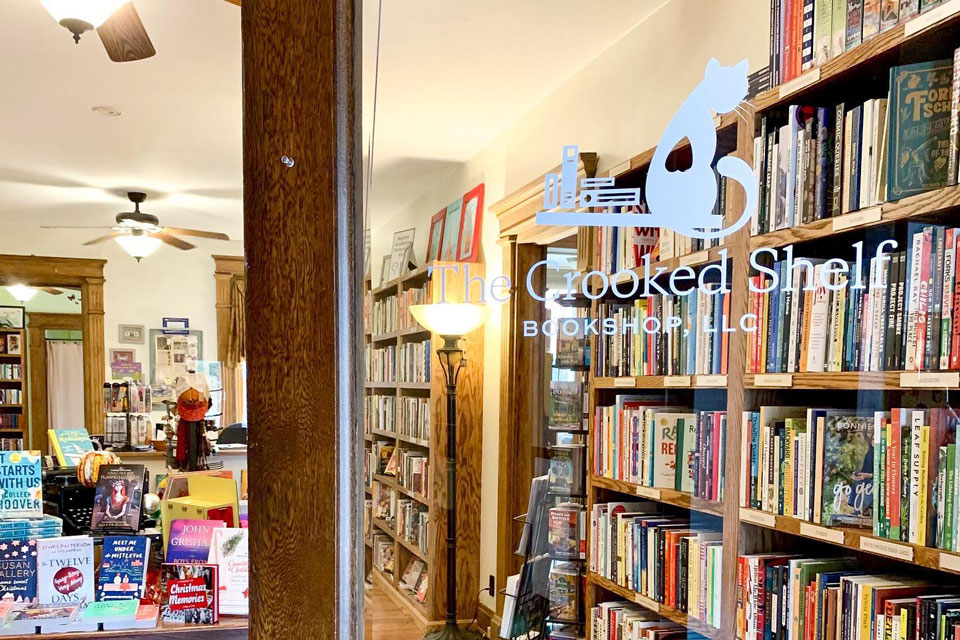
[740,407,875,527]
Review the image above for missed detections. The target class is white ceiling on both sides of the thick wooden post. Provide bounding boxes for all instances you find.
[0,0,666,244]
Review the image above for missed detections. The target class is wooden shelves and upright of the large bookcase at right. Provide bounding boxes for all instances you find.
[580,8,960,640]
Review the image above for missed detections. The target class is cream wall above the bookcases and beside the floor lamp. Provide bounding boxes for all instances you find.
[371,0,769,607]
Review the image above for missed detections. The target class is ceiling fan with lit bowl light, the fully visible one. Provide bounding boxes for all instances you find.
[41,191,230,262]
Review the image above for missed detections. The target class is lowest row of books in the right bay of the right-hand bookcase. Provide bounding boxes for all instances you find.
[736,552,960,640]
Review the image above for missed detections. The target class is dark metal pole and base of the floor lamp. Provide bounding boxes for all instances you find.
[426,336,480,640]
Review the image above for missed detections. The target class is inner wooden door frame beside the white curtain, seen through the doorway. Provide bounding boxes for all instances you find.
[27,312,83,454]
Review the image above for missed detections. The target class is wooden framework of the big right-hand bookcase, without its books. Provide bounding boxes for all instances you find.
[580,10,960,638]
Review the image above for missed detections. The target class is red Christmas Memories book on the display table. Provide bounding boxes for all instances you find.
[160,563,220,624]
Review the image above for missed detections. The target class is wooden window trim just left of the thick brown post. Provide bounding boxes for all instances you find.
[213,255,246,426]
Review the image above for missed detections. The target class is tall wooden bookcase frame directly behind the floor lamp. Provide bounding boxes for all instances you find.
[364,262,483,630]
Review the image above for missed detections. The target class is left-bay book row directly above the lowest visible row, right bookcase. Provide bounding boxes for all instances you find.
[590,502,722,628]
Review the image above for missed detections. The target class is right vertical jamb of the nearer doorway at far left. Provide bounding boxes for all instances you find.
[80,277,107,433]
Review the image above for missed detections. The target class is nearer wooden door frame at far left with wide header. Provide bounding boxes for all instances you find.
[0,255,107,434]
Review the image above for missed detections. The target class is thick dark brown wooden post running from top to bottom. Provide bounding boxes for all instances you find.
[241,0,363,640]
